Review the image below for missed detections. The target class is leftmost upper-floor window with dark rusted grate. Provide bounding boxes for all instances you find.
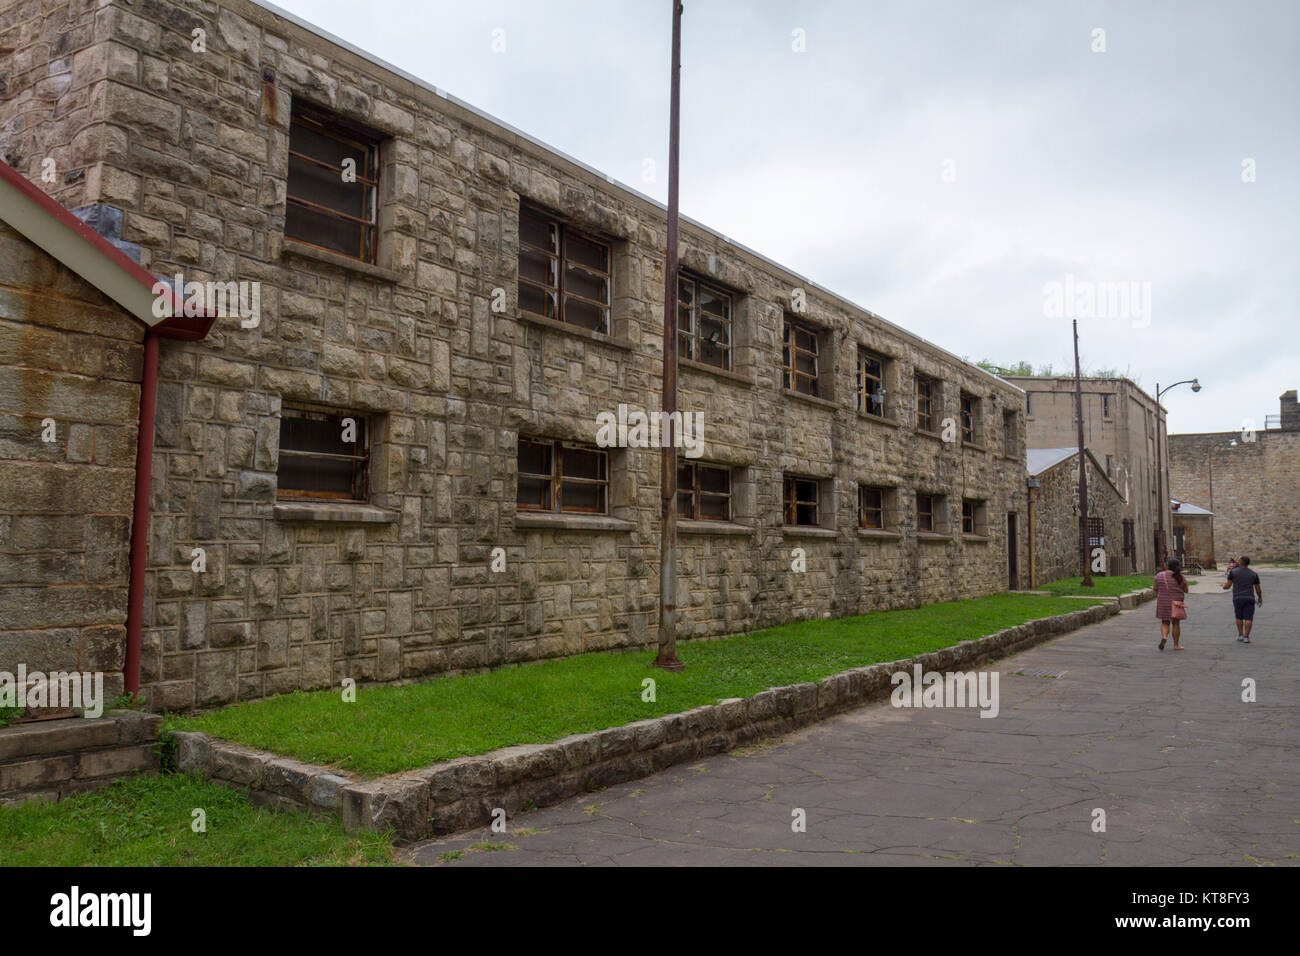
[285,108,380,263]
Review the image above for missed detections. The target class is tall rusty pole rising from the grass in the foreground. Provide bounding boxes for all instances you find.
[654,0,685,671]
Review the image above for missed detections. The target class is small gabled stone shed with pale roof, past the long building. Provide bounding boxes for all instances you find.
[1026,446,1130,588]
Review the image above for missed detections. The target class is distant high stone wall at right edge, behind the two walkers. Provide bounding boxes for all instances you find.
[1169,389,1300,564]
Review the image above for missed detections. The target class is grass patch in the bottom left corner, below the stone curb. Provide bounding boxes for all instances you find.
[0,774,393,866]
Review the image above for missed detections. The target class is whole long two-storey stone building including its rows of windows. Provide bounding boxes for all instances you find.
[0,0,1028,710]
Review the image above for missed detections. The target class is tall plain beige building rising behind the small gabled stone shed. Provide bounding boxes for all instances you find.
[1008,376,1171,574]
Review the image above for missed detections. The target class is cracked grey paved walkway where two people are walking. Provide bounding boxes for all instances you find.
[408,571,1300,866]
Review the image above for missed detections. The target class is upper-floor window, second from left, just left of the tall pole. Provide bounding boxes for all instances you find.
[519,206,610,334]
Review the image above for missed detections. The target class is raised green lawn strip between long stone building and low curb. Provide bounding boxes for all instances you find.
[168,594,1107,777]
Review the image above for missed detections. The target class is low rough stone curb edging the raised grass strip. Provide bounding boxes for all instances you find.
[174,606,1128,840]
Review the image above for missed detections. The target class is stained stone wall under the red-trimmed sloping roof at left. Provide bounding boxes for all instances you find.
[0,224,143,697]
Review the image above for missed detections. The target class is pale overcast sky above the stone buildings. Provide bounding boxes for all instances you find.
[271,0,1300,432]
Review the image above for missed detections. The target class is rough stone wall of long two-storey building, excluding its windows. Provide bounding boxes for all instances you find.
[7,0,1027,709]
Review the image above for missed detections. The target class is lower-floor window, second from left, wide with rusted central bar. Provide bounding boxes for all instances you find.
[515,438,610,515]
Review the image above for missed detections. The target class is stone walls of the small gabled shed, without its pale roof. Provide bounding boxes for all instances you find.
[1034,457,1131,585]
